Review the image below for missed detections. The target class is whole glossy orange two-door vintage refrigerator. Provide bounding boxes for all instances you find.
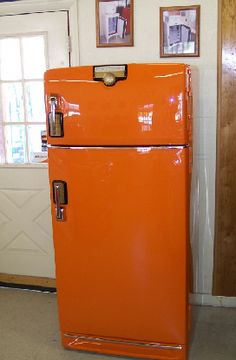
[45,64,192,360]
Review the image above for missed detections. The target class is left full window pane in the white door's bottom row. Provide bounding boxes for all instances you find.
[5,125,26,163]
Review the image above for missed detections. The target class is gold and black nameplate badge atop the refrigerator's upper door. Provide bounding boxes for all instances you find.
[93,65,127,86]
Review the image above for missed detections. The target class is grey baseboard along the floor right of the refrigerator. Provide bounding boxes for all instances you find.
[190,294,236,307]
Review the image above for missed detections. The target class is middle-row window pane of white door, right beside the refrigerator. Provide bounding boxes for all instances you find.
[25,81,46,122]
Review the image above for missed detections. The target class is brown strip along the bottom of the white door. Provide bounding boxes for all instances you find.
[0,273,56,289]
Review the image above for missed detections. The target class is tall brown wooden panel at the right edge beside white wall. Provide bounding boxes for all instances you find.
[213,0,236,297]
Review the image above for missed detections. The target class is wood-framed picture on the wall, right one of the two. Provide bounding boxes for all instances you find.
[160,5,200,57]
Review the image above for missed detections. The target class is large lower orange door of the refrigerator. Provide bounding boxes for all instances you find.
[49,147,189,344]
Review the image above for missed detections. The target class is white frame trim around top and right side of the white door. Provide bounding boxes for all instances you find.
[0,0,79,66]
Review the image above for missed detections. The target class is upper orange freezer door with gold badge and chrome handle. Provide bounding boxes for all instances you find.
[45,64,192,146]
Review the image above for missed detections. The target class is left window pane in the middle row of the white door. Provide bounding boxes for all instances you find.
[2,83,24,122]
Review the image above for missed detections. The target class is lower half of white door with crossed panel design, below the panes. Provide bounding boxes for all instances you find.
[0,165,55,278]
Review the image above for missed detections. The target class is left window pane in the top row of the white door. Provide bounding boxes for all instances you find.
[0,38,21,80]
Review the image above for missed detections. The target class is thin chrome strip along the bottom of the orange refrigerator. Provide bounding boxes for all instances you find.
[64,334,183,350]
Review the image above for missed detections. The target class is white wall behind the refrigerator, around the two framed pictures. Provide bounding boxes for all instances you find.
[78,0,217,294]
